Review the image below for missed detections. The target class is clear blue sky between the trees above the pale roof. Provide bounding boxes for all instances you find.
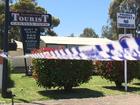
[37,0,111,36]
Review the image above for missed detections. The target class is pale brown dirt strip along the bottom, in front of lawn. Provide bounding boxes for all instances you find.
[15,94,140,105]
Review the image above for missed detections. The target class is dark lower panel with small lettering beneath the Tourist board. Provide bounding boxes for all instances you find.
[21,27,40,53]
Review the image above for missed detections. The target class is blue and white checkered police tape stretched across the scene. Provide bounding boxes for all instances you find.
[0,38,140,61]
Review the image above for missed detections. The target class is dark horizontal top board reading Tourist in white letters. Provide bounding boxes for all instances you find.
[10,12,52,27]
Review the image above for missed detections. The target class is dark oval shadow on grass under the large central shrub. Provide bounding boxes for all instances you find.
[38,88,104,99]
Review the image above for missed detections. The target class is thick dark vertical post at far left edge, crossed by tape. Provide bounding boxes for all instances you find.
[2,0,11,98]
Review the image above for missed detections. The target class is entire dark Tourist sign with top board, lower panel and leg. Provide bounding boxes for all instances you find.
[10,12,52,75]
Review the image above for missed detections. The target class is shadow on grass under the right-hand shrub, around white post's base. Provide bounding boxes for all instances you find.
[103,86,140,92]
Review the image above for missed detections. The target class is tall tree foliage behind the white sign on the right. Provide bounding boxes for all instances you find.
[102,0,140,39]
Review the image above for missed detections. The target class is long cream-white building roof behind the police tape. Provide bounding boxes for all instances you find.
[40,36,112,45]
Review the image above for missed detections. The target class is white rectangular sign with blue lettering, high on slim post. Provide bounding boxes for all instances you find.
[117,13,135,29]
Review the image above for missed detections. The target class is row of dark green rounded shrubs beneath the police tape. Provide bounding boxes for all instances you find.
[33,49,140,91]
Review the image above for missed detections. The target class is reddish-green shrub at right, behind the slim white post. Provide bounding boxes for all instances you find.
[96,61,137,87]
